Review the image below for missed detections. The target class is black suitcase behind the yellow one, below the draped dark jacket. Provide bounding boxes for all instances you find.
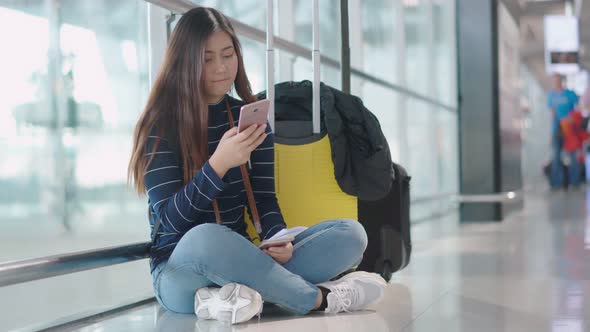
[357,163,412,281]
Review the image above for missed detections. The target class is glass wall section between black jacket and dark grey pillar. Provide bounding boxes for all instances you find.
[349,0,458,199]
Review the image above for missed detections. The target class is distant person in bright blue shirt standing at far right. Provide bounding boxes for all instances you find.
[547,74,581,190]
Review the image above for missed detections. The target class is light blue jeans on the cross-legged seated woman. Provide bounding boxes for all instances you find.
[152,219,367,315]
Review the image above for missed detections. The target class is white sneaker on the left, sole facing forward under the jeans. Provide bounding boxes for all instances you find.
[195,283,262,324]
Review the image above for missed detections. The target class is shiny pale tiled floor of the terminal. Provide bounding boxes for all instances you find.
[10,191,590,332]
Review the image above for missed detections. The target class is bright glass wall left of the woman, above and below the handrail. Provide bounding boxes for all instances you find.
[0,0,151,329]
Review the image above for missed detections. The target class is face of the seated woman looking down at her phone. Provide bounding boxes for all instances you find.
[203,31,238,104]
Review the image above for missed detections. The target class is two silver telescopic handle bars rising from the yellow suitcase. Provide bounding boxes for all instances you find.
[266,0,321,134]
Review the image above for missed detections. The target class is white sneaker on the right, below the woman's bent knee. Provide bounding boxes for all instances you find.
[318,272,387,314]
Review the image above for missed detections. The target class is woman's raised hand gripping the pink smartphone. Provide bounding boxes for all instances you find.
[209,124,266,178]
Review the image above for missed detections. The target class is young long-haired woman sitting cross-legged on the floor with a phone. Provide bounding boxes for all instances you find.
[129,7,386,323]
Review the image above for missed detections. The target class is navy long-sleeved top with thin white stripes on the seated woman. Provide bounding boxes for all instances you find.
[144,96,285,271]
